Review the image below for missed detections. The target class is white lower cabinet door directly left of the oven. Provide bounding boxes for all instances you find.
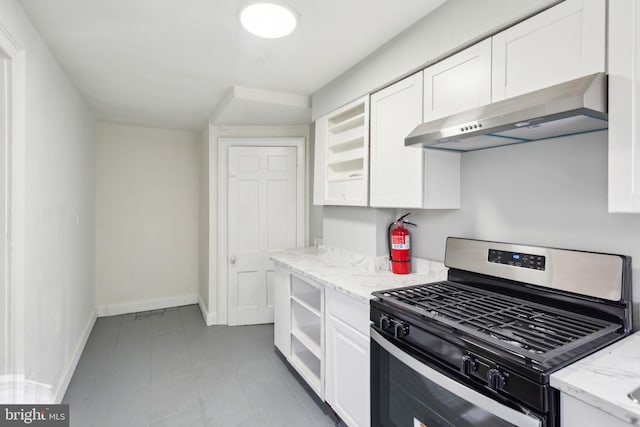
[325,314,371,427]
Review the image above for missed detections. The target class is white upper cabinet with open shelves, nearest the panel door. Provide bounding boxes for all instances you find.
[313,95,369,206]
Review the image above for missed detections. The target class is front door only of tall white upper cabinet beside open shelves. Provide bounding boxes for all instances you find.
[370,73,423,208]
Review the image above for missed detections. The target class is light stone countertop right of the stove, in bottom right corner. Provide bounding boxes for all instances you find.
[551,332,640,426]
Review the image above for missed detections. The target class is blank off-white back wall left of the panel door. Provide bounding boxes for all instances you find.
[96,123,201,315]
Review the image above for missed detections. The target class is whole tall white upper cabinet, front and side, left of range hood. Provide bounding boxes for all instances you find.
[370,73,460,209]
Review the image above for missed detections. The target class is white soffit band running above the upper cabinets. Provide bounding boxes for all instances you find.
[312,0,558,119]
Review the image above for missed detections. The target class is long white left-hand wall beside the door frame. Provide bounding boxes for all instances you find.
[0,0,95,402]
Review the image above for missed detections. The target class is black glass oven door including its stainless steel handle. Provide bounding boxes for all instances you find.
[371,328,544,427]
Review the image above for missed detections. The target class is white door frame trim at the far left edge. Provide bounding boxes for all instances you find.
[0,26,26,403]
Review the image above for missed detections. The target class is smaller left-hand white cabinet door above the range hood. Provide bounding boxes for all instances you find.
[424,39,491,122]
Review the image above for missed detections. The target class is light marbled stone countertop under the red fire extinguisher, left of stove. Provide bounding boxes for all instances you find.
[271,248,447,303]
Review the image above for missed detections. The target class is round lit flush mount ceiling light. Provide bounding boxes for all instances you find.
[240,3,296,39]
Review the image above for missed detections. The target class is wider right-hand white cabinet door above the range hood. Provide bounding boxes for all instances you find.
[491,0,606,102]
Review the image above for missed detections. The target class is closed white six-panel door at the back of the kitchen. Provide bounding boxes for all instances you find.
[228,146,297,325]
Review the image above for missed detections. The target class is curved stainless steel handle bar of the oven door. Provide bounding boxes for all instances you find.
[371,328,542,427]
